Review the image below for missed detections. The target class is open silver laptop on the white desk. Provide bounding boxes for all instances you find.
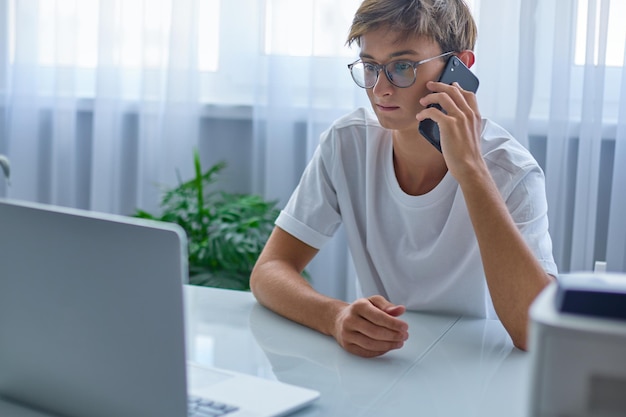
[0,199,319,417]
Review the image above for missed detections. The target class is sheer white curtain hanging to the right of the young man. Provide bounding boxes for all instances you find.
[479,0,626,271]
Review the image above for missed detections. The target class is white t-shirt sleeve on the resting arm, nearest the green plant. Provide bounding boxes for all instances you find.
[276,130,341,249]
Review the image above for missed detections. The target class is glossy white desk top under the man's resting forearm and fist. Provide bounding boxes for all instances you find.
[185,287,529,417]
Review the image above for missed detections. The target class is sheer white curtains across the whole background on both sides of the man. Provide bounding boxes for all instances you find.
[0,0,626,298]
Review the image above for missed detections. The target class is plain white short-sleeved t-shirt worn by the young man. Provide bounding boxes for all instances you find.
[276,108,557,318]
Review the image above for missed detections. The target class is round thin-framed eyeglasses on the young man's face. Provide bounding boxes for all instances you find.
[348,52,454,88]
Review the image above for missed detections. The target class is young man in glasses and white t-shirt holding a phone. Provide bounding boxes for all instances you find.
[251,0,557,357]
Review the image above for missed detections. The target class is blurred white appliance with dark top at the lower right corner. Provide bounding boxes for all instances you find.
[528,273,626,417]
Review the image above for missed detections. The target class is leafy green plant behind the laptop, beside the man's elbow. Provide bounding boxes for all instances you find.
[135,151,278,291]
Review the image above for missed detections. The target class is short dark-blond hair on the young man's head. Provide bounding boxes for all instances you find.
[346,0,477,52]
